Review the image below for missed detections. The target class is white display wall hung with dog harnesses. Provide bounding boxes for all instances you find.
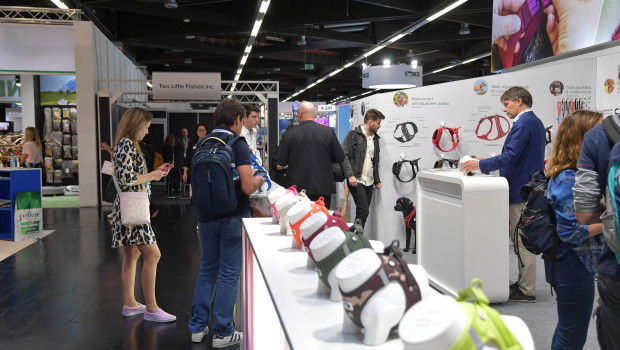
[348,47,620,244]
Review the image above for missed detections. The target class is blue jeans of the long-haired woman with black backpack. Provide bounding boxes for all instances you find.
[545,250,594,350]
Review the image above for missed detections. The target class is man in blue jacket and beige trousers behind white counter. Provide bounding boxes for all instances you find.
[461,86,545,303]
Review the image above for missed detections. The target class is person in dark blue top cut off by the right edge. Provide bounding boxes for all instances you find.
[573,115,620,350]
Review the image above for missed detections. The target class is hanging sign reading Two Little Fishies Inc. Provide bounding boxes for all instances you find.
[153,72,222,101]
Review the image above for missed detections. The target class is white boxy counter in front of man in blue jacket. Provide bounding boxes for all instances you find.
[416,169,509,302]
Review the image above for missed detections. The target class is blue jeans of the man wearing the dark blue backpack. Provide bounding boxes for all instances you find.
[189,212,249,336]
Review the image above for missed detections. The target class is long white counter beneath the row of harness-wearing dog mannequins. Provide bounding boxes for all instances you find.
[242,218,412,350]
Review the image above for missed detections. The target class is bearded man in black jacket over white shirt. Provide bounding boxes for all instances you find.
[342,108,385,227]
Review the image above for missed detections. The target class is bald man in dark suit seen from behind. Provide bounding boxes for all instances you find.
[278,102,344,208]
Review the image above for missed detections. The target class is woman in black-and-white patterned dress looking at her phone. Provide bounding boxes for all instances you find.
[112,107,176,322]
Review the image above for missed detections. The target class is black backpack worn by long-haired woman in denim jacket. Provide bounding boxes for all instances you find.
[514,171,560,286]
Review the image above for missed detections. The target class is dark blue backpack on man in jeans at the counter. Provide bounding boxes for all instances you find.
[191,133,240,215]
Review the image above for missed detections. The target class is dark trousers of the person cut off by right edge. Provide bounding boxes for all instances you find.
[596,273,620,350]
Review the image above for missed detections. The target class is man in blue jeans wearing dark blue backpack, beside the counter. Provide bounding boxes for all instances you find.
[189,98,265,348]
